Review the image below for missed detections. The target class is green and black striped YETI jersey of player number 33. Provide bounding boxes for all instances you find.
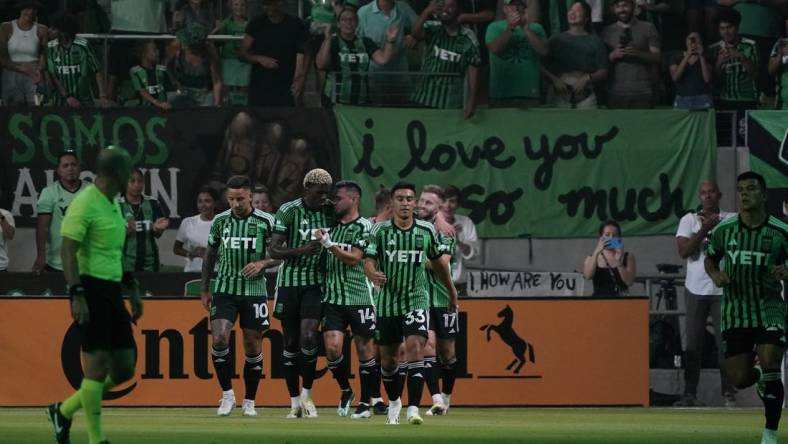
[364,220,447,317]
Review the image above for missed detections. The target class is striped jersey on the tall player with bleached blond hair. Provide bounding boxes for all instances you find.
[274,198,335,287]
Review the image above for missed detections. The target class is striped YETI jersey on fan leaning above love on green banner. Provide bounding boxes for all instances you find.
[411,22,481,108]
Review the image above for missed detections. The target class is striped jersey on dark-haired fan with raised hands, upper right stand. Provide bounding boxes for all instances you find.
[709,37,759,102]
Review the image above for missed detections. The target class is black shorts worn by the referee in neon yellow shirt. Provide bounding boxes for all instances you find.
[80,276,137,352]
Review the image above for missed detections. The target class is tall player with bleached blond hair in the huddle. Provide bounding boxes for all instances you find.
[271,168,334,419]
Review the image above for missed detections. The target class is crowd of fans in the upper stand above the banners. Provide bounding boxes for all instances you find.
[0,0,788,111]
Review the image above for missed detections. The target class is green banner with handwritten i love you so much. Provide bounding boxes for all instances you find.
[335,106,716,237]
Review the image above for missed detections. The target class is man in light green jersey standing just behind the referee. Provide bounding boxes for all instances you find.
[33,151,88,273]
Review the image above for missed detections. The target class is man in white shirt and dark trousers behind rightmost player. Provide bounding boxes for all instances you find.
[675,181,736,407]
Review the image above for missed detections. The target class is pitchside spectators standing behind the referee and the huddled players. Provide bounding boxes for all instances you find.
[0,151,479,298]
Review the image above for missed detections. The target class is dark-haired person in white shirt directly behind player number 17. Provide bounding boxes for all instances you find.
[444,185,479,295]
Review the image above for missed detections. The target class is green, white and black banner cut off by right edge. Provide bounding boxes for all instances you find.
[747,111,788,217]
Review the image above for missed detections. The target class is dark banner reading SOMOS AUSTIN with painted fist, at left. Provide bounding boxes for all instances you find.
[0,108,339,226]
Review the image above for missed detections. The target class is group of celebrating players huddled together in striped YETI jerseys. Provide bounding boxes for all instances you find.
[202,169,459,424]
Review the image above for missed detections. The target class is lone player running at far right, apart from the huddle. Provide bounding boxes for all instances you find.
[704,172,788,444]
